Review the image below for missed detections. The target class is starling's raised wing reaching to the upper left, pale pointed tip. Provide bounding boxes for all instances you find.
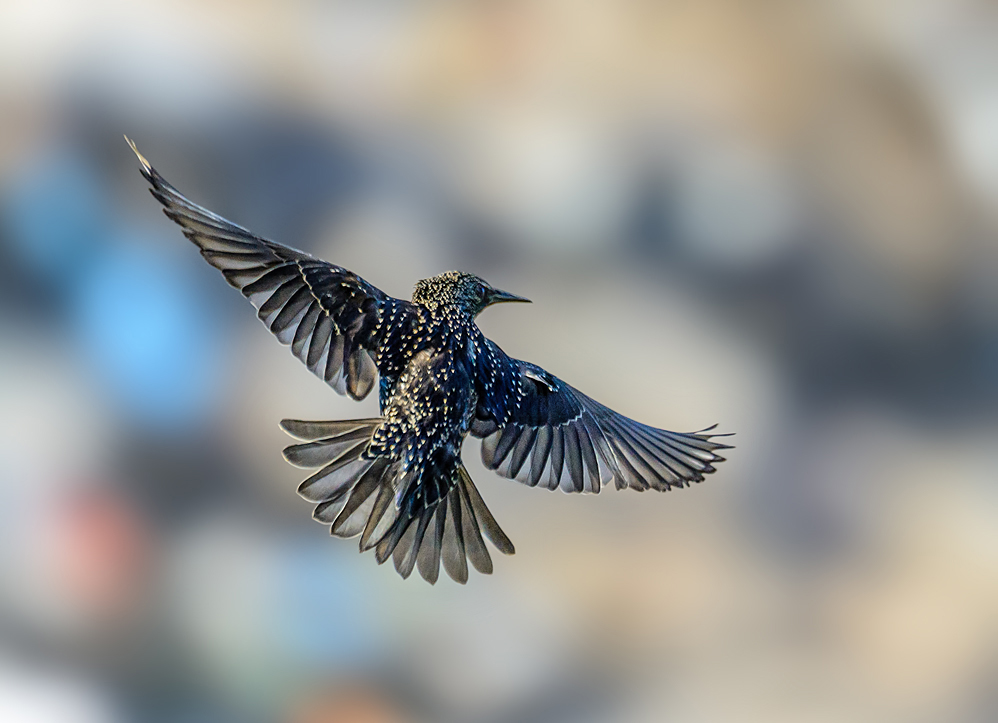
[126,138,412,399]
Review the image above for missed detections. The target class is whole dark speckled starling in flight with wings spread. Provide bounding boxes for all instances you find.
[126,138,728,584]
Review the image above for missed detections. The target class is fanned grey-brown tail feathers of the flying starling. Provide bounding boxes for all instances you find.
[281,417,514,584]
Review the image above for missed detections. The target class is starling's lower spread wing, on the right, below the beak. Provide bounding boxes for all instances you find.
[471,337,730,492]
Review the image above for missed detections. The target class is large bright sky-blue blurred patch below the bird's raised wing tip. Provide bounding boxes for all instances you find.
[70,232,221,431]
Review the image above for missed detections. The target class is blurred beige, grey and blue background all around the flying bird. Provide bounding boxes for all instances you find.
[0,0,998,723]
